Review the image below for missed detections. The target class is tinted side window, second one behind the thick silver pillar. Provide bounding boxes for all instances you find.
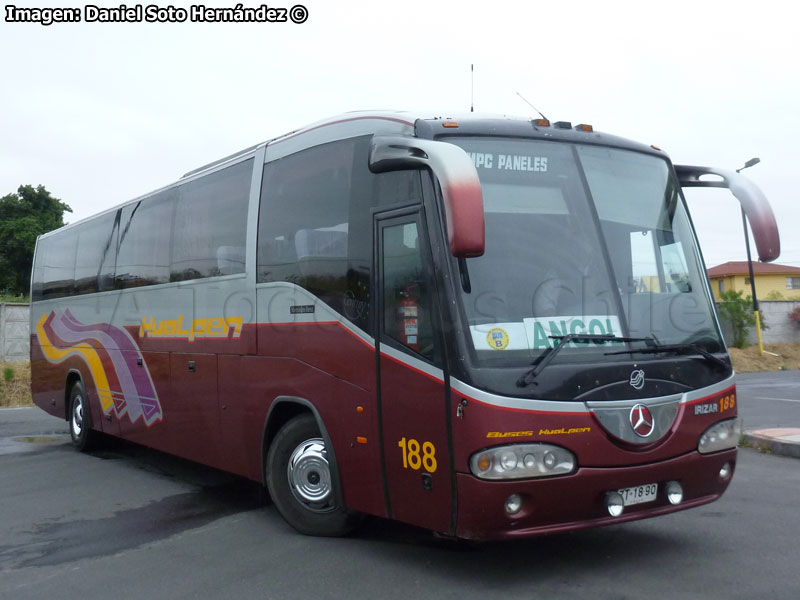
[115,188,176,288]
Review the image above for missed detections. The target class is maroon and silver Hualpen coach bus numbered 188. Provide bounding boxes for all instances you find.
[31,112,779,540]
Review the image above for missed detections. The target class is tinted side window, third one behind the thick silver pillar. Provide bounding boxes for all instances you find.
[75,213,116,294]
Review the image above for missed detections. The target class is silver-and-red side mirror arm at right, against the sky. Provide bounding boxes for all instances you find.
[675,165,781,262]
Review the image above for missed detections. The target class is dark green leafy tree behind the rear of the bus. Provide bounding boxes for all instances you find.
[0,185,72,295]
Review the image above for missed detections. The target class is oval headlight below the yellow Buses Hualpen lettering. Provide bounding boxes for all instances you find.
[469,444,577,479]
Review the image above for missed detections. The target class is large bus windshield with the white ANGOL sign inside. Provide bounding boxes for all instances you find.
[448,137,724,367]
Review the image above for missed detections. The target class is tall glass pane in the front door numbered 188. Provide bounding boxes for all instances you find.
[382,223,433,360]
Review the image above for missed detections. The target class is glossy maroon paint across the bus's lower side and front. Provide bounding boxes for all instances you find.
[31,323,736,538]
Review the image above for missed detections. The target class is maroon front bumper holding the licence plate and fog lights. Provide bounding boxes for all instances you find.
[456,449,736,539]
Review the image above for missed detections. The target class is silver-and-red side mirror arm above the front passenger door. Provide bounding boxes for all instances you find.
[369,136,486,258]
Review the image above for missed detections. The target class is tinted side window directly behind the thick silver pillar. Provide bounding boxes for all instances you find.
[170,159,253,281]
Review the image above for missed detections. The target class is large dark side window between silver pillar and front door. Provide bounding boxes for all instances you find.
[257,137,421,332]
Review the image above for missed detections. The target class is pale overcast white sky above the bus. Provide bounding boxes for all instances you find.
[0,0,800,266]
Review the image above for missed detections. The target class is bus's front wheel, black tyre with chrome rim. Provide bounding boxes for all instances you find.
[266,414,359,536]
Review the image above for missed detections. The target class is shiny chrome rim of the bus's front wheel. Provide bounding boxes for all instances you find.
[287,438,336,512]
